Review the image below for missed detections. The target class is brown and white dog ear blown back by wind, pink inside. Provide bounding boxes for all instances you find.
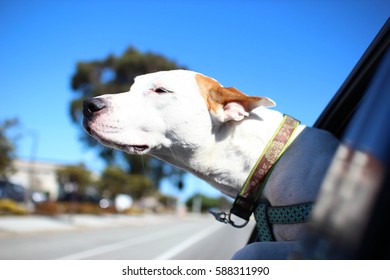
[210,87,276,122]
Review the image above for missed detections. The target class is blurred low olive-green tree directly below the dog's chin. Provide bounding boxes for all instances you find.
[99,166,156,200]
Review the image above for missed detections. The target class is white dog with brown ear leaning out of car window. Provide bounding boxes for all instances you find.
[84,70,338,241]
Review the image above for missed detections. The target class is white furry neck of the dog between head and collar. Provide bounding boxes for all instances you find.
[153,107,303,197]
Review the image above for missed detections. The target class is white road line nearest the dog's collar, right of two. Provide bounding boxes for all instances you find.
[154,224,221,260]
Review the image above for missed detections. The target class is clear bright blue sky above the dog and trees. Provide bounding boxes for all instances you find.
[0,0,390,200]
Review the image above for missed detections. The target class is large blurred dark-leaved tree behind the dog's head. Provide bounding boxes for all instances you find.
[70,47,184,186]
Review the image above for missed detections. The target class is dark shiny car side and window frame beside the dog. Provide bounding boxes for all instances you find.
[291,20,390,259]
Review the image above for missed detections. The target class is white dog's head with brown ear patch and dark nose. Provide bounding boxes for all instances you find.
[83,70,275,159]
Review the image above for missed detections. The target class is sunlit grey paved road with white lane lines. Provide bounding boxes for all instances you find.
[0,216,253,260]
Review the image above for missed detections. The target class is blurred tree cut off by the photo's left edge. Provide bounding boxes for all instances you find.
[0,119,18,179]
